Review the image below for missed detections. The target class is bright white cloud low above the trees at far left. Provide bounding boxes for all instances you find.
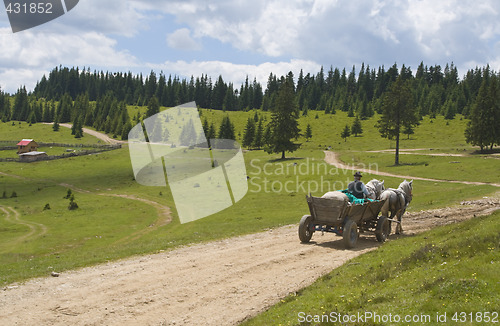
[0,28,137,92]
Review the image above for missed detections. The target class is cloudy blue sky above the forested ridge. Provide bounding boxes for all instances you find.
[0,0,500,93]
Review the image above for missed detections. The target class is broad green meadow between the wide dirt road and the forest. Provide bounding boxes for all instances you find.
[0,107,498,285]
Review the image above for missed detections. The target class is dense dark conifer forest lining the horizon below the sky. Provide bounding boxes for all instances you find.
[0,63,500,154]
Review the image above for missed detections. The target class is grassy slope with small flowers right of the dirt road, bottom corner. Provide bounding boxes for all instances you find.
[242,211,500,326]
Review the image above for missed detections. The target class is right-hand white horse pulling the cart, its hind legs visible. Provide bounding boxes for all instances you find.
[380,180,413,234]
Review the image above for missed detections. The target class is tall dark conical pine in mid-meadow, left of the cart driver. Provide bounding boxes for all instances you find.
[266,72,300,159]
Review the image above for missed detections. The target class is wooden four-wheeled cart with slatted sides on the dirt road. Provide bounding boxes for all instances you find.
[299,192,391,248]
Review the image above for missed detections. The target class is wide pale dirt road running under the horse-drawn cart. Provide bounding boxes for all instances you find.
[0,196,500,326]
